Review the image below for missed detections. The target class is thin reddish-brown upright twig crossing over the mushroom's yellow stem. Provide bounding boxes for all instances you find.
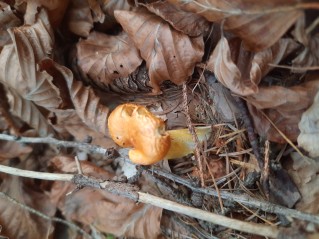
[183,82,205,187]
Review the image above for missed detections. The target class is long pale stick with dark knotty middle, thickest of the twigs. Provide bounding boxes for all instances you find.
[0,165,279,238]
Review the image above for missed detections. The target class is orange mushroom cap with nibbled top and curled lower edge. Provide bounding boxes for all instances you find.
[108,104,171,165]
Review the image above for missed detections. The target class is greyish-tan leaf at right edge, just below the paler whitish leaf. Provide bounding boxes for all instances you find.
[288,152,319,214]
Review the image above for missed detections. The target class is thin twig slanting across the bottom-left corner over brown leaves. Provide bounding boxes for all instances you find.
[0,192,92,238]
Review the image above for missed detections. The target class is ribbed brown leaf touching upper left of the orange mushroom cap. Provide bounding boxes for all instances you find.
[61,66,110,134]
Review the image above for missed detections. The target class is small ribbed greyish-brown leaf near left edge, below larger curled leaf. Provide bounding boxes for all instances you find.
[7,89,54,137]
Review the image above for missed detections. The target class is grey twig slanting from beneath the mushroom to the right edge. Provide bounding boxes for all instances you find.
[148,168,319,224]
